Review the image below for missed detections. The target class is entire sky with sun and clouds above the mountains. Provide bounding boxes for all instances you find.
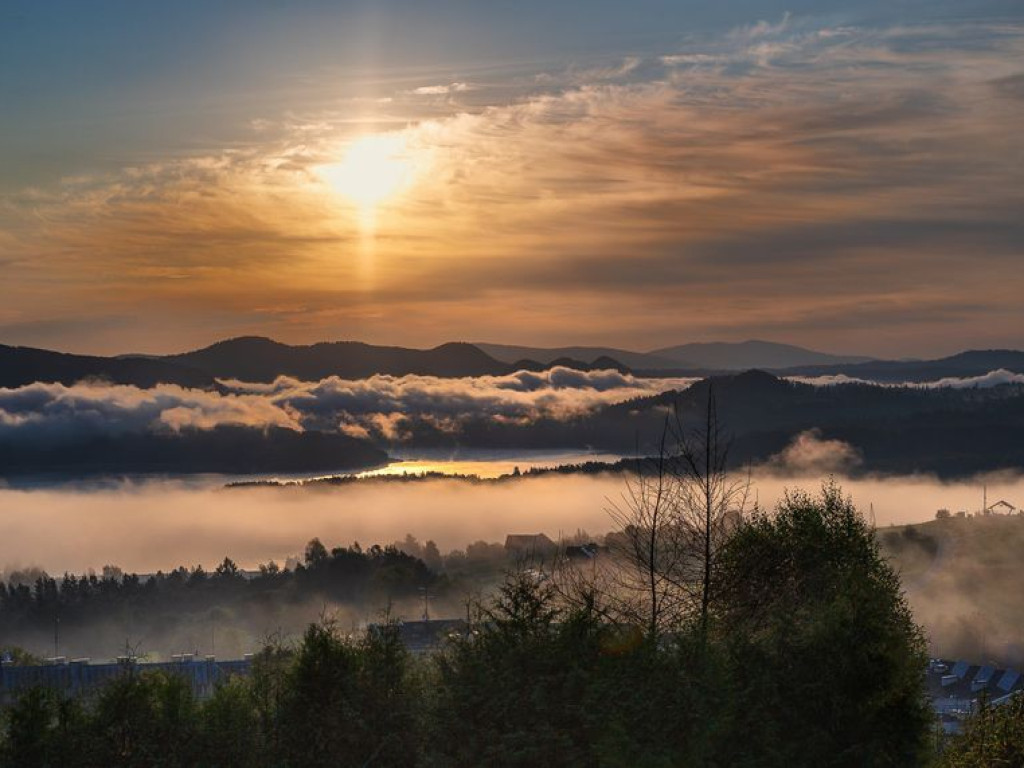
[0,0,1024,356]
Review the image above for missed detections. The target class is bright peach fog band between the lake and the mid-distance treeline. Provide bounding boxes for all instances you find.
[0,465,1024,573]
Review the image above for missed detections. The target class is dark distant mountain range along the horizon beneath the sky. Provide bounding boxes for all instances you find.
[0,337,1024,389]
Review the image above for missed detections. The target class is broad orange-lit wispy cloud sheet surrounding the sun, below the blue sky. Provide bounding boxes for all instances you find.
[0,17,1024,354]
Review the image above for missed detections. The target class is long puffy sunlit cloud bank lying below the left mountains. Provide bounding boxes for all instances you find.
[0,368,693,441]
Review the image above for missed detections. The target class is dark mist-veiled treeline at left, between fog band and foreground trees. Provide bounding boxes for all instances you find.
[0,539,446,658]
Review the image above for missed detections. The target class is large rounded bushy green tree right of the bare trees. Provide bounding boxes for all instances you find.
[715,482,931,766]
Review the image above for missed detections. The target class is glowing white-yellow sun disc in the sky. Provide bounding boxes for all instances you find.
[319,133,414,208]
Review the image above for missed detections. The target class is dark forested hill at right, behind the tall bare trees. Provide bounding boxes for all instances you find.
[393,371,1024,477]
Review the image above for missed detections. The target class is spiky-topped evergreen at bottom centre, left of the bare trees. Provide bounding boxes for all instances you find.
[432,571,599,768]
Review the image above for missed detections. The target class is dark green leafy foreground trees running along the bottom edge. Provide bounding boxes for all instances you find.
[2,486,966,768]
